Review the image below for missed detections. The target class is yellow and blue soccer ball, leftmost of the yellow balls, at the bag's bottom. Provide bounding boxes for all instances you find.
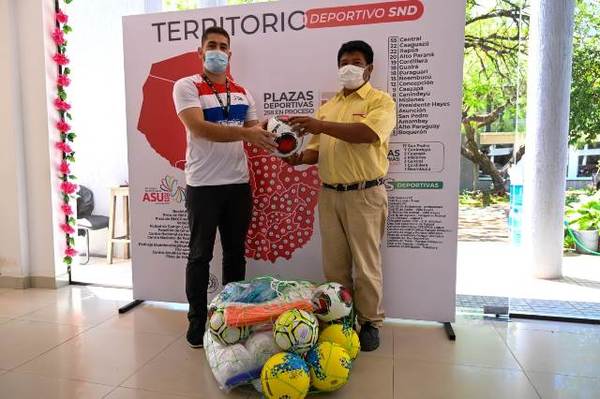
[260,352,310,399]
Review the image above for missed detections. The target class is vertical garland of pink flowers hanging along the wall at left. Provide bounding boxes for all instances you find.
[51,0,79,268]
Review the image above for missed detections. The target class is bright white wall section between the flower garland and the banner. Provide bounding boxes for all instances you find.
[68,0,145,219]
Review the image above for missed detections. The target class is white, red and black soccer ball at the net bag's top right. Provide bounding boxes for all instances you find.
[312,283,352,322]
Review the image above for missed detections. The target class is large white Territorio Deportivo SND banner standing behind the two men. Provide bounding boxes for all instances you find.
[123,0,465,321]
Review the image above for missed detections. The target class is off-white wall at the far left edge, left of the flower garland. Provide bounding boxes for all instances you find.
[0,0,66,278]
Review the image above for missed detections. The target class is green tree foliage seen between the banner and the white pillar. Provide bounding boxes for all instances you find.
[463,0,529,131]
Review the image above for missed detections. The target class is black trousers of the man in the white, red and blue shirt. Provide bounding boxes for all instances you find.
[185,184,252,324]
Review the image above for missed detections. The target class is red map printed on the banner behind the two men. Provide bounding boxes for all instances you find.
[138,52,320,262]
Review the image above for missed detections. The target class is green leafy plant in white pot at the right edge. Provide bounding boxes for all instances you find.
[565,195,600,254]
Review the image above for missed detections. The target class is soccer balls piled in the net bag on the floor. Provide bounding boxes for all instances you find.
[208,283,360,399]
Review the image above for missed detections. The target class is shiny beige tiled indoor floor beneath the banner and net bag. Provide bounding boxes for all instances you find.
[0,287,600,399]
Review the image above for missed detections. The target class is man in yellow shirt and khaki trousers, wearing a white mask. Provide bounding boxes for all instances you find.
[287,41,396,351]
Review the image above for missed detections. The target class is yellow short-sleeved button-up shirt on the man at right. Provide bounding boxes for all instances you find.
[307,82,396,184]
